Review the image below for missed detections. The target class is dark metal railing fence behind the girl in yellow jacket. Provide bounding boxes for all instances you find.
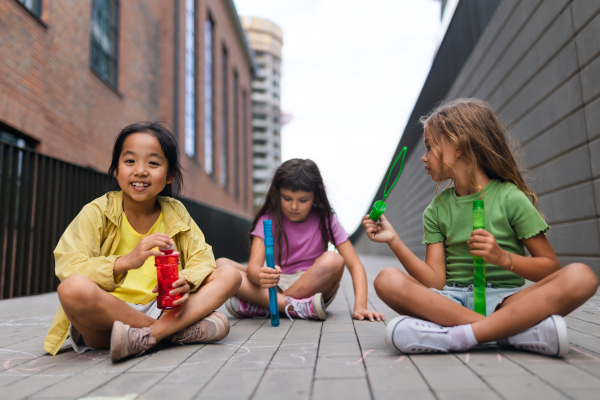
[0,142,250,299]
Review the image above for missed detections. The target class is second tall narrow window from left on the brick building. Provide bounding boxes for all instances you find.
[204,19,213,175]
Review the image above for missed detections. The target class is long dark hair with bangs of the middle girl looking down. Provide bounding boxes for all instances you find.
[250,158,333,266]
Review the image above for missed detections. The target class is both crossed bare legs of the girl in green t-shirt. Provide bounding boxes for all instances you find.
[374,263,598,343]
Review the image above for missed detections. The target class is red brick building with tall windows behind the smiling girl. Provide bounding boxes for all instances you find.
[0,0,253,218]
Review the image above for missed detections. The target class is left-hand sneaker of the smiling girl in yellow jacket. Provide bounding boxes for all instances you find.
[110,321,156,362]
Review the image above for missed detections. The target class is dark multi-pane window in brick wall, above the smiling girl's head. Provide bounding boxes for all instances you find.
[90,0,119,89]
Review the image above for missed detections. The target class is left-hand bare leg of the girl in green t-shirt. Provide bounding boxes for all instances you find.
[374,267,485,326]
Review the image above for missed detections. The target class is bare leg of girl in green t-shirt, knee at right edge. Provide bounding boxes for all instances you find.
[472,263,598,343]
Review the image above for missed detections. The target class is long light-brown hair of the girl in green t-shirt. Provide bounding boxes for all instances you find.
[420,99,538,209]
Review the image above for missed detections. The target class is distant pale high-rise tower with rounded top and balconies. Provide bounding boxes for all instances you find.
[241,17,283,207]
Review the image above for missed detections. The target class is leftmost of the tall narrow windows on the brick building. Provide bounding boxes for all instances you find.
[185,0,196,157]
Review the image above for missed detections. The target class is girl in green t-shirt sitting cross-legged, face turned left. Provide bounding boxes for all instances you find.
[362,99,598,356]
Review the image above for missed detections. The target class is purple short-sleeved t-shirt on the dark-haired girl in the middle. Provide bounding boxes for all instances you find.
[250,208,350,274]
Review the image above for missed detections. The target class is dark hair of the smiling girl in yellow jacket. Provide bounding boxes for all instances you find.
[108,121,183,197]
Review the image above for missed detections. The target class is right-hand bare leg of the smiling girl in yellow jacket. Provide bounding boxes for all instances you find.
[152,266,241,341]
